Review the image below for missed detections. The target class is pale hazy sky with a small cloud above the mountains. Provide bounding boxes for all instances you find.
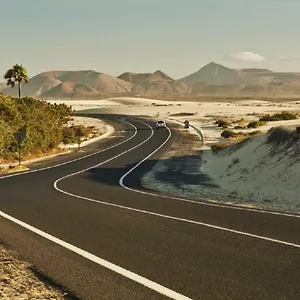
[0,0,300,78]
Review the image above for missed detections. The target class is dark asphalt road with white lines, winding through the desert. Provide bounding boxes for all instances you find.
[0,116,300,300]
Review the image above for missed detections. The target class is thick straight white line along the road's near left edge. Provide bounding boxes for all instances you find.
[0,211,192,300]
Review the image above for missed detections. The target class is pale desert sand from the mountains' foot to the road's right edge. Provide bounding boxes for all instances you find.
[47,97,300,213]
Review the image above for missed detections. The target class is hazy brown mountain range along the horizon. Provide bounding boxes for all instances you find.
[0,62,300,99]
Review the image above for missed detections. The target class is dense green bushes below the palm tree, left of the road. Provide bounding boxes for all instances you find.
[0,94,72,160]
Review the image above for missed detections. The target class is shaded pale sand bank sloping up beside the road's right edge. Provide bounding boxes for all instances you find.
[201,133,300,213]
